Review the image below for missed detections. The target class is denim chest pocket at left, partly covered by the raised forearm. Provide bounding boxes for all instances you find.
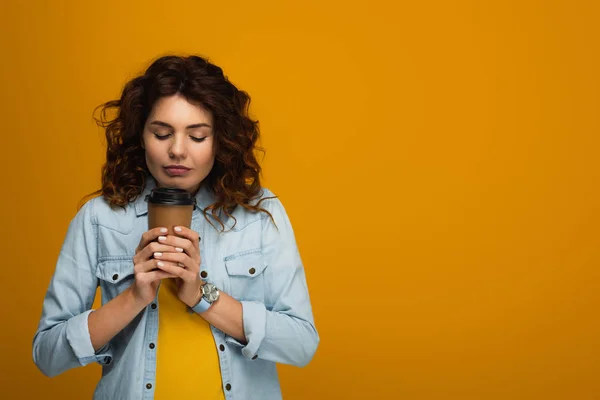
[96,259,134,304]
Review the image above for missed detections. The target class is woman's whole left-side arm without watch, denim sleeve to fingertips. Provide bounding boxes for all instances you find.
[33,201,173,376]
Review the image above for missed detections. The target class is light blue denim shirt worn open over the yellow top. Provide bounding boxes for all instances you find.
[33,180,319,400]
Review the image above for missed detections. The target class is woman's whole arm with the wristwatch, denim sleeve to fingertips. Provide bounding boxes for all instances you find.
[155,199,319,366]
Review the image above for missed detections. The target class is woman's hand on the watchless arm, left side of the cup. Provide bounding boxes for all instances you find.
[130,228,176,306]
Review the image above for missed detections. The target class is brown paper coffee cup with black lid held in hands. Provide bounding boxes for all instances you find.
[146,188,196,235]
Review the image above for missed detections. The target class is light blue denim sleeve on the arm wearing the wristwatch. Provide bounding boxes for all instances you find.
[232,198,320,366]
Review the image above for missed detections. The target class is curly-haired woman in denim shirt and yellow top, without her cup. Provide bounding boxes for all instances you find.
[33,56,319,400]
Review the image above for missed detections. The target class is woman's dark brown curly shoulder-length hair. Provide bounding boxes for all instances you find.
[87,55,272,229]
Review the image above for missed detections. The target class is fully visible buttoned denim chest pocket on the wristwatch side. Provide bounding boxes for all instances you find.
[225,249,266,302]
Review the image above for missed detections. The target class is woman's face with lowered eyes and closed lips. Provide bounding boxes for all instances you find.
[142,94,215,193]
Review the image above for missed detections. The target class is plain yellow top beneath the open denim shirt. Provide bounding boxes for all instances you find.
[154,279,225,400]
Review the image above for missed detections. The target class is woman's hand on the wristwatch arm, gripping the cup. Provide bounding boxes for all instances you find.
[154,226,204,307]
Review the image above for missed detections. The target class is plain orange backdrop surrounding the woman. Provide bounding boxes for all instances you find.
[0,0,600,400]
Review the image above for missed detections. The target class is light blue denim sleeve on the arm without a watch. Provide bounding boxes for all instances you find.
[33,201,111,376]
